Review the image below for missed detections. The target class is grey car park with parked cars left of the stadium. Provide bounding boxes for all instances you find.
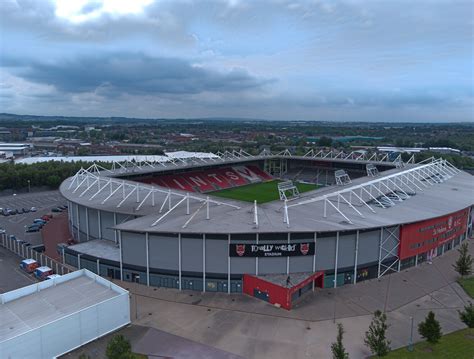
[0,191,66,245]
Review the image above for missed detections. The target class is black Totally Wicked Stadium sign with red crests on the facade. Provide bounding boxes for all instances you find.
[229,242,314,257]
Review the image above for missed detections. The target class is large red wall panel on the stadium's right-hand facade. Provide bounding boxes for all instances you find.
[399,208,469,259]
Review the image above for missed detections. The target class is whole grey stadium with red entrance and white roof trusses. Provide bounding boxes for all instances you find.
[59,150,474,309]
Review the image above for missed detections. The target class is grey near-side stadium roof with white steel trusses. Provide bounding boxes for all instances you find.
[61,153,474,233]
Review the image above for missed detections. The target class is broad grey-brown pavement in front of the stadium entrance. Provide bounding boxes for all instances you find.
[113,240,474,359]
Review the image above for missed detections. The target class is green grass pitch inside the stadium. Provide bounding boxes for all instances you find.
[211,180,318,203]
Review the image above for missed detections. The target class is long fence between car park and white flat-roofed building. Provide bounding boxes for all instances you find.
[0,233,76,275]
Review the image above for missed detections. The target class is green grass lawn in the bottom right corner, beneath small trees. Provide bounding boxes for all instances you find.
[384,328,474,359]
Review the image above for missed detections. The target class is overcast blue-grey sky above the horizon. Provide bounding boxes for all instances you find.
[0,0,474,122]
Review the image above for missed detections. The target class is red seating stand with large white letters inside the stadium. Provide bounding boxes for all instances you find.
[140,166,273,193]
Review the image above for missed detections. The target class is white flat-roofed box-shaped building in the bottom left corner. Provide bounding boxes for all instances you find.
[0,269,130,359]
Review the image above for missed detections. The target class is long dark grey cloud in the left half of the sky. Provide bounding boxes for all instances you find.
[9,53,272,97]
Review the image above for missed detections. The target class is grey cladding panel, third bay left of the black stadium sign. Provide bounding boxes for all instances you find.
[148,234,179,270]
